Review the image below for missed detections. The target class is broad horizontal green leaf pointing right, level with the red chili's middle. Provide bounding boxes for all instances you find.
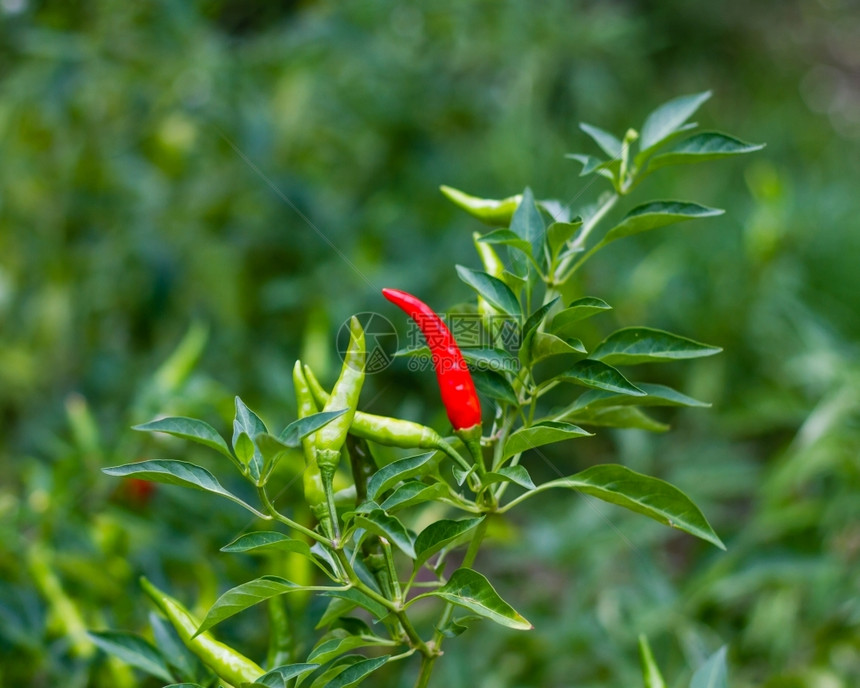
[591,327,722,365]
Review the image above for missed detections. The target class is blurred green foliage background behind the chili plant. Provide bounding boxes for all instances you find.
[0,0,860,688]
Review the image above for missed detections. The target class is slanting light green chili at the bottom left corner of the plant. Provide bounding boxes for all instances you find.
[140,578,266,686]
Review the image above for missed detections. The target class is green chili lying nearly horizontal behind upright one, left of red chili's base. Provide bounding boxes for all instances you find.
[304,366,470,470]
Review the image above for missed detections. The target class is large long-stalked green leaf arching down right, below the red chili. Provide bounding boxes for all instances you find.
[527,464,726,549]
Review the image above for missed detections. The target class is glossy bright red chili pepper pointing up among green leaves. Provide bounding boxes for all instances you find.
[382,289,481,431]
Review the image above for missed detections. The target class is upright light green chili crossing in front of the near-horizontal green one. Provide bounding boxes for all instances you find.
[310,316,366,478]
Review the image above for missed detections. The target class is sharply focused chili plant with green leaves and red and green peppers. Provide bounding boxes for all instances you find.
[97,93,761,688]
